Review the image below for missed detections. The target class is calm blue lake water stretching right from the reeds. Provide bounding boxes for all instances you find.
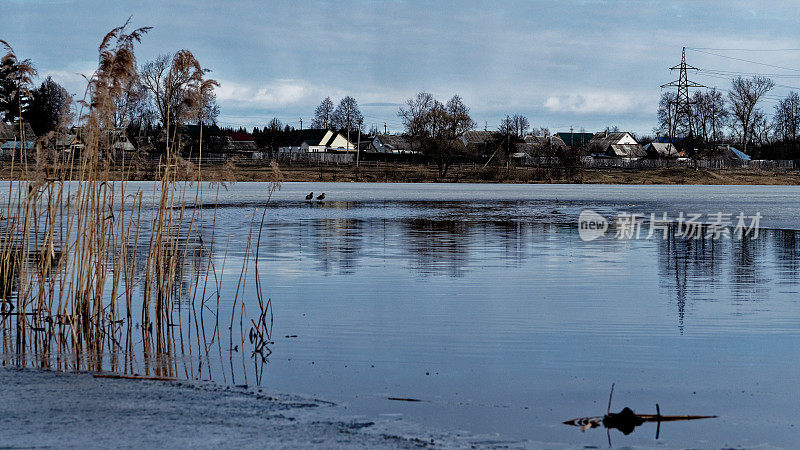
[7,183,800,447]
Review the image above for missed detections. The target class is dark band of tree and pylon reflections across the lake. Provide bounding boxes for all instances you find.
[265,209,800,333]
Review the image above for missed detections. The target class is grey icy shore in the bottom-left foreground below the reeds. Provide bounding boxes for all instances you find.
[0,368,533,448]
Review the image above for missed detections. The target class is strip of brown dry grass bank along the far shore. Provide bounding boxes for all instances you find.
[0,162,800,186]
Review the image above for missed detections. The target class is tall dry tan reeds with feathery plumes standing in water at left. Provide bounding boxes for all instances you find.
[0,23,280,384]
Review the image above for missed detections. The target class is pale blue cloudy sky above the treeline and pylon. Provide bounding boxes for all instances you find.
[0,0,800,133]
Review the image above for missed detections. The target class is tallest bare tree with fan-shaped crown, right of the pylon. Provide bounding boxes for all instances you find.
[728,76,775,153]
